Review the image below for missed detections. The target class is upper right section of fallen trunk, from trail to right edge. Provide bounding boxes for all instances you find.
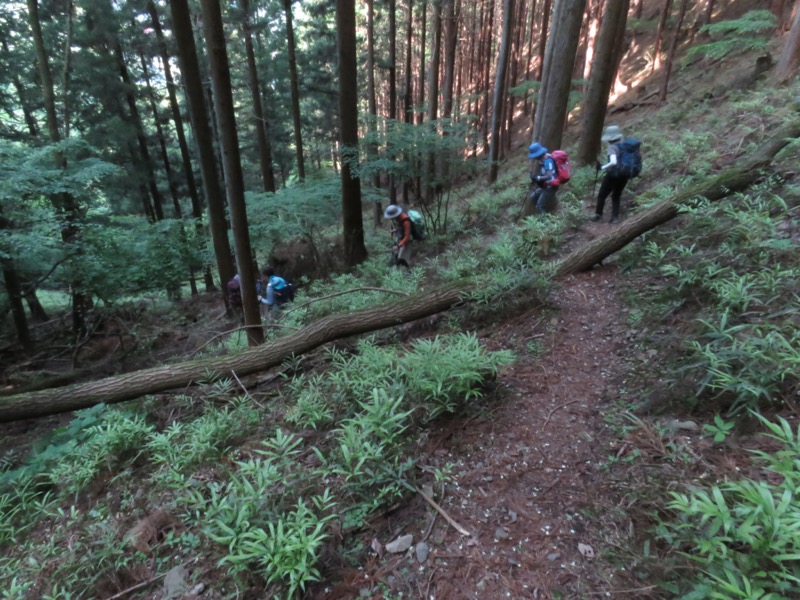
[555,121,800,277]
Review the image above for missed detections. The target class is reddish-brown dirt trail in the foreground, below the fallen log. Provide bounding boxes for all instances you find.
[350,267,645,600]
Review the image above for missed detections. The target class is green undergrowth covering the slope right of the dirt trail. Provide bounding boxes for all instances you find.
[620,170,800,599]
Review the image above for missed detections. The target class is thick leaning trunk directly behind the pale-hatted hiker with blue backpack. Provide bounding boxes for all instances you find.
[576,0,630,165]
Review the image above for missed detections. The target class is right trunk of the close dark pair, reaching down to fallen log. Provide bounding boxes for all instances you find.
[200,0,264,346]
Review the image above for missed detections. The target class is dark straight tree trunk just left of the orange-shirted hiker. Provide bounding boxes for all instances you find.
[336,0,367,267]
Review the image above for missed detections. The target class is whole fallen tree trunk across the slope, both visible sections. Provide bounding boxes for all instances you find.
[0,121,800,423]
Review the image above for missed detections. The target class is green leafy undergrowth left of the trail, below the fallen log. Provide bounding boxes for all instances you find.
[0,334,513,599]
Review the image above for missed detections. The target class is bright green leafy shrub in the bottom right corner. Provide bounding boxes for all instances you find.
[659,417,800,600]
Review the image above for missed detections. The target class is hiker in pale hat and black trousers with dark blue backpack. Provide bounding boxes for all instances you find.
[590,125,642,223]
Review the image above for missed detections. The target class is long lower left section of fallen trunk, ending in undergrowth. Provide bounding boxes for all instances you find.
[0,285,463,423]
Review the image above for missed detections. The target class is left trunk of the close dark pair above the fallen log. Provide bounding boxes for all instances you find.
[169,0,236,298]
